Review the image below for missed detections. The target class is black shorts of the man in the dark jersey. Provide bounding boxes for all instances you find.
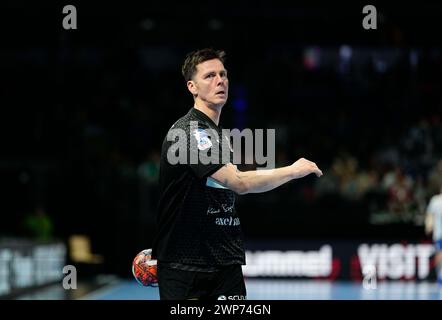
[158,264,246,300]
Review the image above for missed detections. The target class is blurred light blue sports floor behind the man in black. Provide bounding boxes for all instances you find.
[80,279,442,300]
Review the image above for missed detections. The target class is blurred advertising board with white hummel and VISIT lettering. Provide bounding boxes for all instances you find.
[243,241,435,281]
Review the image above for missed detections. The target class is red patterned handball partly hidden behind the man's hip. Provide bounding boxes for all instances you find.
[132,249,158,287]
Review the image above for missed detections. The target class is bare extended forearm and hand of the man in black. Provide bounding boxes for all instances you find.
[212,158,322,194]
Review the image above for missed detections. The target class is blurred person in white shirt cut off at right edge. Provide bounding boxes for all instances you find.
[425,186,442,285]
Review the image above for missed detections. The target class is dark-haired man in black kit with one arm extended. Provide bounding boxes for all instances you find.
[152,49,322,300]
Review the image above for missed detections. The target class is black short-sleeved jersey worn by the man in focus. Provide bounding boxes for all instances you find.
[152,108,245,266]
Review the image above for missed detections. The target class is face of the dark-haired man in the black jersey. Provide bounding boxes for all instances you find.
[187,59,229,107]
